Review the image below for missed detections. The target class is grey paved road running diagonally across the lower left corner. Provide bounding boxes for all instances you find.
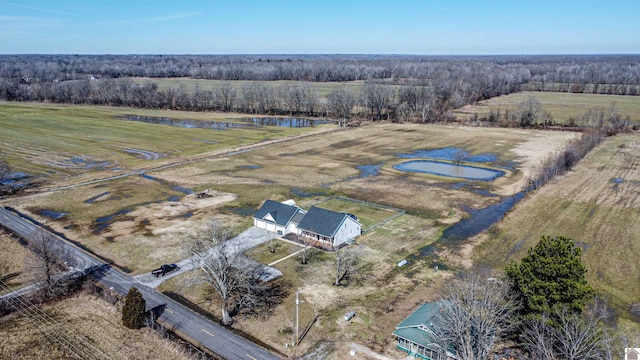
[0,207,279,360]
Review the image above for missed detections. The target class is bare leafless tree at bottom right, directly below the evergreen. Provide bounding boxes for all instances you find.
[521,309,613,360]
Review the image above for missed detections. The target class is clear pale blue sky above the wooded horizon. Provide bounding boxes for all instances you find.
[0,0,640,55]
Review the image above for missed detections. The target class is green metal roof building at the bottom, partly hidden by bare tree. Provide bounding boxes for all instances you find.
[393,302,457,360]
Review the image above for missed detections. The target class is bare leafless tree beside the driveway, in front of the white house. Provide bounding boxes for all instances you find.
[186,222,267,325]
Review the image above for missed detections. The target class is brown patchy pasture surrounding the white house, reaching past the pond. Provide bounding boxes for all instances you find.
[4,102,600,355]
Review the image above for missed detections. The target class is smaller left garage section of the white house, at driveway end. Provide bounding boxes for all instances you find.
[253,200,306,235]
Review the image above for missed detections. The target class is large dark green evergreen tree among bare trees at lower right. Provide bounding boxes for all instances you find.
[505,236,595,317]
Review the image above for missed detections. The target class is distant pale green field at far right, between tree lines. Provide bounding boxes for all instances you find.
[454,91,640,124]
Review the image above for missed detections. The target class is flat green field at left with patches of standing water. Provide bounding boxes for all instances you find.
[0,102,331,186]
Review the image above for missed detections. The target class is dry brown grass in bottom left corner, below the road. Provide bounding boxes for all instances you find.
[0,294,191,360]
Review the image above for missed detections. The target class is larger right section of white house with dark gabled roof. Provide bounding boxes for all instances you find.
[298,206,362,248]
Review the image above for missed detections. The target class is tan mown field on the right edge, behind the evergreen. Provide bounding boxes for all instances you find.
[473,134,640,326]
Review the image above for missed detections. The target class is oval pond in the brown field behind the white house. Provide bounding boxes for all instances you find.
[393,160,505,181]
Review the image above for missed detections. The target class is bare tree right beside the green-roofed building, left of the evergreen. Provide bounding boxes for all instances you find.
[436,275,517,360]
